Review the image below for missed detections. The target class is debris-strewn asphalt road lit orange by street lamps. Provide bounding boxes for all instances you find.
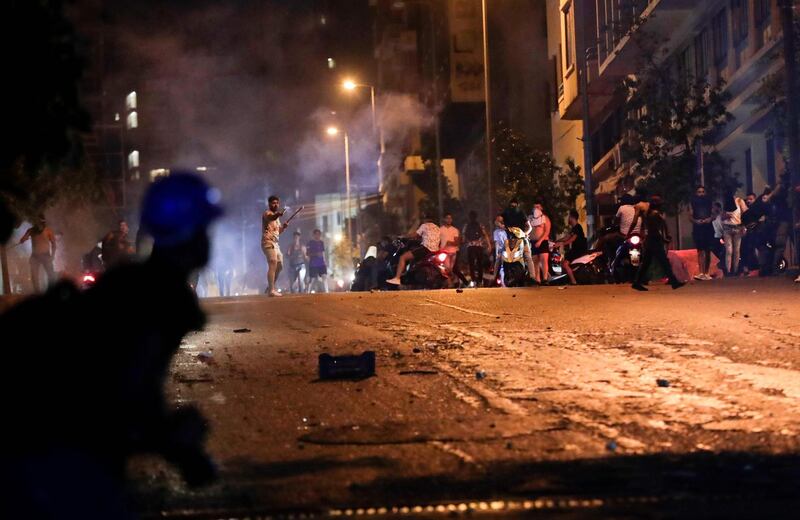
[131,279,800,518]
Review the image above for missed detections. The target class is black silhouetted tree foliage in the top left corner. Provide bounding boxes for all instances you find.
[0,0,96,215]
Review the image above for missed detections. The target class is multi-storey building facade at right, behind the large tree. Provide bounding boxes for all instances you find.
[547,0,783,246]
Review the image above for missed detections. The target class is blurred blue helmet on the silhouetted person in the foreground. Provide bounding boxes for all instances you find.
[141,171,223,246]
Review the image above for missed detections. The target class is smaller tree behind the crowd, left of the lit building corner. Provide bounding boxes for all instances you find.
[494,127,583,233]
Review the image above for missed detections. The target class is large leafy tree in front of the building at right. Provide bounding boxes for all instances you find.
[621,27,733,214]
